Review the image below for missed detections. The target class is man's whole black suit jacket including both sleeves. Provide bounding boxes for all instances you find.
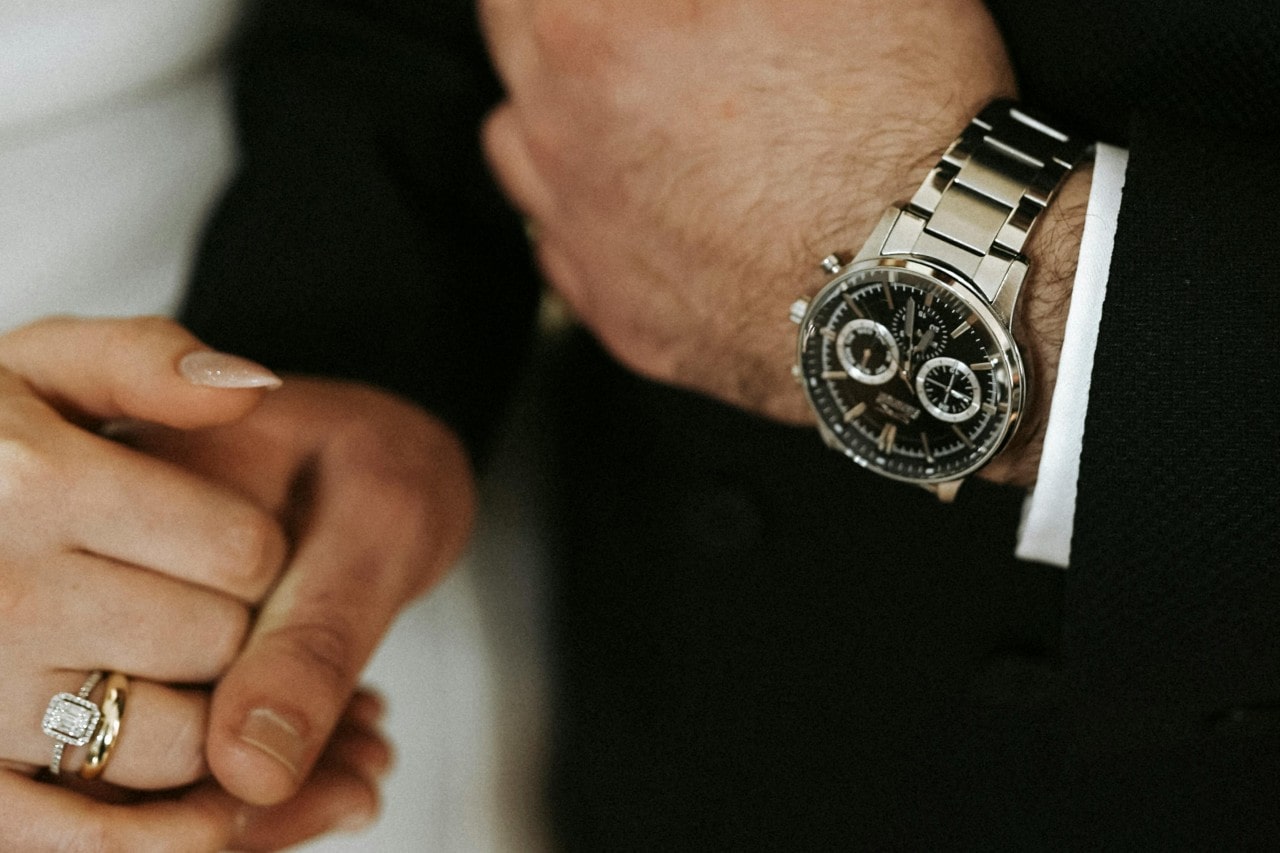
[186,0,1280,850]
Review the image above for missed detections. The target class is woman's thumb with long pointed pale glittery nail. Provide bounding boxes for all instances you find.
[0,318,280,428]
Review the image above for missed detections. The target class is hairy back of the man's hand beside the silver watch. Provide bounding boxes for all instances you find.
[480,0,1014,423]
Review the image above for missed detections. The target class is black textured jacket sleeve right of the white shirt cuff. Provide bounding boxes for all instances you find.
[1068,115,1280,702]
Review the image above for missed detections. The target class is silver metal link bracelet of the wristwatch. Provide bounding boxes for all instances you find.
[879,100,1092,302]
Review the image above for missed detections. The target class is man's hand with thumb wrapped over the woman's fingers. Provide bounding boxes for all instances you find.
[132,378,475,804]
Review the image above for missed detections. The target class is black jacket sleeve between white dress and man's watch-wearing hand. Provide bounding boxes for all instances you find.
[183,0,536,466]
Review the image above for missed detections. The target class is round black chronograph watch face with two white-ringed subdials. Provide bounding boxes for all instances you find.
[799,257,1023,483]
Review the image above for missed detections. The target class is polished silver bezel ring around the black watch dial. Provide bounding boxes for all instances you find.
[795,255,1028,487]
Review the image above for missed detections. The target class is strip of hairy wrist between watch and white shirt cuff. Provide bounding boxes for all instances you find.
[980,163,1093,487]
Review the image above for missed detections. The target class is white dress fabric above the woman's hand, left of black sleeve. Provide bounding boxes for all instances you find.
[0,0,238,329]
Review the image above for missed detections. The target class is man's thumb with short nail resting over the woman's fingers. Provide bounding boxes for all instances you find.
[209,394,474,804]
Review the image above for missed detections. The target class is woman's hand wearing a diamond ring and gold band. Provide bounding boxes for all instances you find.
[0,319,287,789]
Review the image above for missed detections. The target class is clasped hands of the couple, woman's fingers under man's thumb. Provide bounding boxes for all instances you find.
[0,320,471,850]
